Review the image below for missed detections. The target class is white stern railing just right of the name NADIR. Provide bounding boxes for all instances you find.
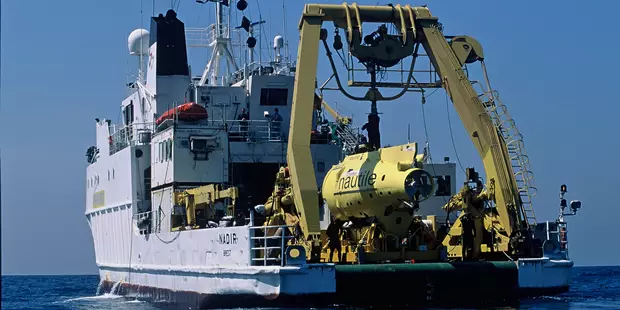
[250,225,294,266]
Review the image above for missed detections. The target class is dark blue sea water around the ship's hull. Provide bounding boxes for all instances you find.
[1,266,620,310]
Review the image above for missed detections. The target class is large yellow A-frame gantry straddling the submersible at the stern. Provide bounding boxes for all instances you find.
[264,3,535,259]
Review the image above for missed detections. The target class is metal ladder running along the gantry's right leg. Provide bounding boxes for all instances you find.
[479,90,537,227]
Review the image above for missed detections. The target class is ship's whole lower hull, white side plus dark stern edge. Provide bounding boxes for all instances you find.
[91,206,572,308]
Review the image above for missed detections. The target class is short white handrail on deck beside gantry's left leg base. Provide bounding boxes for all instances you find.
[250,225,294,266]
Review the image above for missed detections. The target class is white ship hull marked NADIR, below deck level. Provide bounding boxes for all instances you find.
[91,203,573,307]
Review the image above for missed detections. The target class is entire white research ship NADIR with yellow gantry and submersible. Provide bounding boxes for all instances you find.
[85,0,581,308]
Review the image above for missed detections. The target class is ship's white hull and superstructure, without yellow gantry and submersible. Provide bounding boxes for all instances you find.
[86,1,576,308]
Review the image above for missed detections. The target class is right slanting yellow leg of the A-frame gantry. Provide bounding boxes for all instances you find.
[417,14,521,236]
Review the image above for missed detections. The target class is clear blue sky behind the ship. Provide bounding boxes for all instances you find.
[0,0,620,274]
